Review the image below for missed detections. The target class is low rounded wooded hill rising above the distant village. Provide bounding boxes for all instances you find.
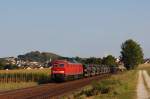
[18,51,61,62]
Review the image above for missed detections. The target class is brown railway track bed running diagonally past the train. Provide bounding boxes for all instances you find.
[0,74,109,99]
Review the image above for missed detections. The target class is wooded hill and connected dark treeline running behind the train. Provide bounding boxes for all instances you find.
[18,51,117,65]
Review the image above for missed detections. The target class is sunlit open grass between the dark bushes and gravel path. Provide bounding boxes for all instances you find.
[97,71,137,99]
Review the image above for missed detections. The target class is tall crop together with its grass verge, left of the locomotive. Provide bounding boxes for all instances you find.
[0,69,50,91]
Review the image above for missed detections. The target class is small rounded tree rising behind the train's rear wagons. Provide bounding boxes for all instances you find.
[102,55,117,66]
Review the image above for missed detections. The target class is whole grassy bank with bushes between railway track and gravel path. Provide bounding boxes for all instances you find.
[66,70,137,99]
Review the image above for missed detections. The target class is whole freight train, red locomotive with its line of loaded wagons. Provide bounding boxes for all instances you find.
[51,60,117,81]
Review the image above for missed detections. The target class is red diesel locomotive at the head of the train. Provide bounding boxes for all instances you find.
[51,60,83,81]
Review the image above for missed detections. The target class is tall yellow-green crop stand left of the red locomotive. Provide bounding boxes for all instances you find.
[0,69,50,84]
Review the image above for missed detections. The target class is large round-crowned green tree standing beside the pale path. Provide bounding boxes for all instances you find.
[120,39,144,70]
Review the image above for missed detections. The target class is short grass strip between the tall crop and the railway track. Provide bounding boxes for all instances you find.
[0,82,38,91]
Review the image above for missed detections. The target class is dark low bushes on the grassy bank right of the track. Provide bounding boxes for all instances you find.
[74,79,121,99]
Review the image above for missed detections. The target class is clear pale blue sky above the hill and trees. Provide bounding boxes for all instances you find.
[0,0,150,57]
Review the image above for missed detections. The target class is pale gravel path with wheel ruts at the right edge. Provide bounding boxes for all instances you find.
[137,70,150,99]
